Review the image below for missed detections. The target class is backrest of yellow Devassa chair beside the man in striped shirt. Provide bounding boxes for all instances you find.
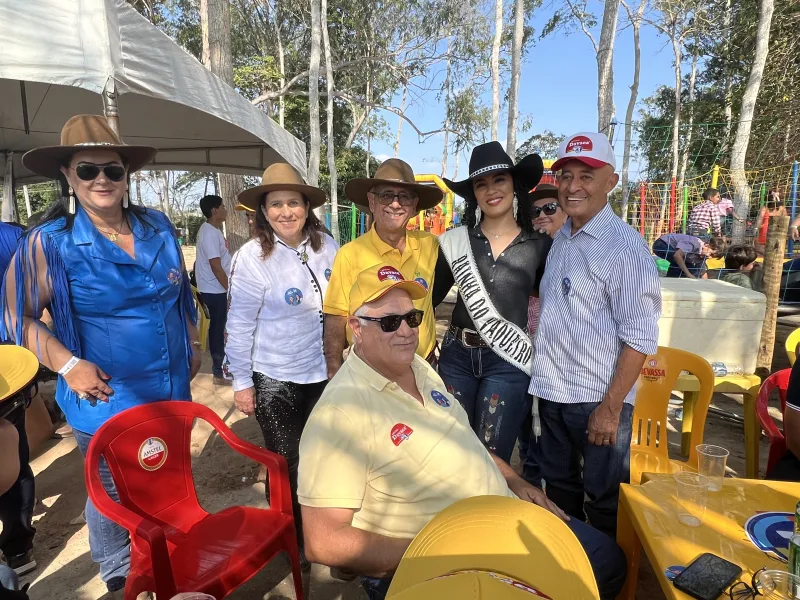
[631,346,714,464]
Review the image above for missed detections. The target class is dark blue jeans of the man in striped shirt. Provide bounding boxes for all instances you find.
[539,399,633,538]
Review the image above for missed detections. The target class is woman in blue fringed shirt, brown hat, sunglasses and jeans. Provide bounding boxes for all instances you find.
[0,115,200,592]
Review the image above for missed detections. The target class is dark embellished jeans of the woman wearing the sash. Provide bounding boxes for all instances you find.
[439,331,530,462]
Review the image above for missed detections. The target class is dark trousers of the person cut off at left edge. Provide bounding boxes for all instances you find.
[0,407,36,558]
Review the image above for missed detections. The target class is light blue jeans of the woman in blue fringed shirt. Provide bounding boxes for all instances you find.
[72,429,131,581]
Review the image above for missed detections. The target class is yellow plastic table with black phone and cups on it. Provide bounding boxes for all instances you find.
[617,473,800,600]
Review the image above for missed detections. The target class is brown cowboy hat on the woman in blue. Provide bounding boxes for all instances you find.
[22,115,158,179]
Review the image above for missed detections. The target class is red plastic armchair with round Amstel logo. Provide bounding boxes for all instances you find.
[84,401,303,600]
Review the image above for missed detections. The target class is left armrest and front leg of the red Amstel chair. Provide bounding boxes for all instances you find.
[84,440,176,598]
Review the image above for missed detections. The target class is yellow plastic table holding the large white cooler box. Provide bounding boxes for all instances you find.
[675,373,761,479]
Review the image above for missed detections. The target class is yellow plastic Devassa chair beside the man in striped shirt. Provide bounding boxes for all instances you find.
[630,346,714,485]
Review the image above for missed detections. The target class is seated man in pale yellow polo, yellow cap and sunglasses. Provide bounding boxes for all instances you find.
[298,264,625,598]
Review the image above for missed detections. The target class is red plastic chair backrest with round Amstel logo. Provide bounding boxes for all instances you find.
[91,401,203,526]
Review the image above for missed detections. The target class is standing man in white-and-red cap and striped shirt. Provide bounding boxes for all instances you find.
[529,133,661,536]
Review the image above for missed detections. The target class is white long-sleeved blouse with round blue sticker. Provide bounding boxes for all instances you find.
[225,233,339,391]
